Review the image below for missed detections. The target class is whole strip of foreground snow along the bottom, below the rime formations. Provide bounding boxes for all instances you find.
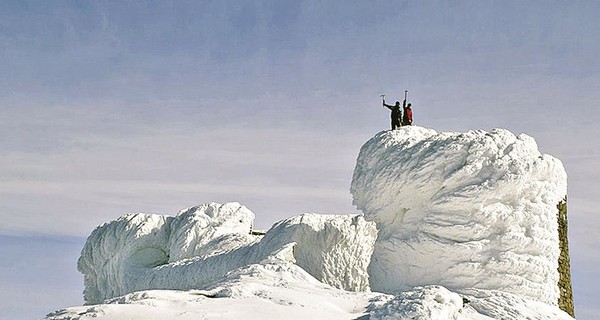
[46,278,573,320]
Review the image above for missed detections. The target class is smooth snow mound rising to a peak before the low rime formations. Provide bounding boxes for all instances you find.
[47,244,381,320]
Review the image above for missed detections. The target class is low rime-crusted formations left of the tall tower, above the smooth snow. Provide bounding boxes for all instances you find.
[78,203,377,303]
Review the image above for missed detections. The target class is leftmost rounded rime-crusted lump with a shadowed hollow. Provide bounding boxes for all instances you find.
[77,203,257,303]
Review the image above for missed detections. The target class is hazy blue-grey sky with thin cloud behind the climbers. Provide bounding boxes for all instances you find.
[0,0,600,319]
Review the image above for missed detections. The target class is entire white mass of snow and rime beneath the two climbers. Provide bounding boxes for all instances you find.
[46,127,572,320]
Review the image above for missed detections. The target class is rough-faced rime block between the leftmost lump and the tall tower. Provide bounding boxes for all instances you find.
[260,214,377,291]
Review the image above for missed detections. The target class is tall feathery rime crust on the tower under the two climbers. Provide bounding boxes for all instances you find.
[351,127,567,305]
